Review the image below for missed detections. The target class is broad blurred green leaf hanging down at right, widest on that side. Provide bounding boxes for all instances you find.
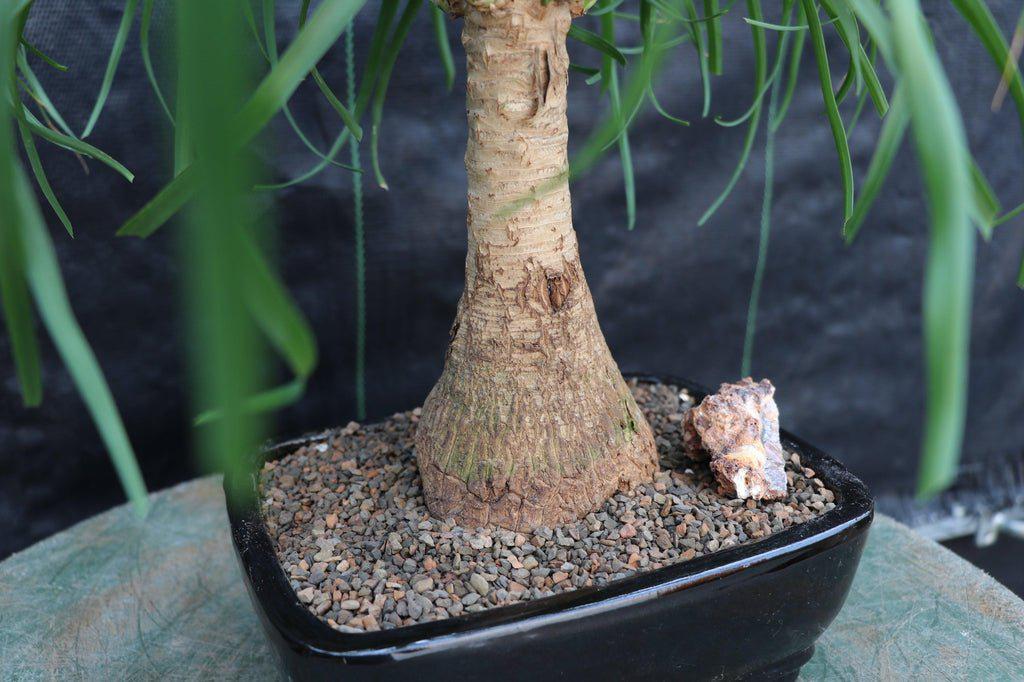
[889,0,975,497]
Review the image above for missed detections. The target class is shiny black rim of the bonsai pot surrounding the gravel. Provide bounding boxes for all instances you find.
[224,374,873,663]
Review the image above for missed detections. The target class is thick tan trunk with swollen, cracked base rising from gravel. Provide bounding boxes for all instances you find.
[416,0,656,529]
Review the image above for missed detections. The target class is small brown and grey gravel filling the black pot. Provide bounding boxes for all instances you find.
[261,381,835,632]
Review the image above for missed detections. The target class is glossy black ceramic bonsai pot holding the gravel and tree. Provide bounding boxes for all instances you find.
[225,377,873,682]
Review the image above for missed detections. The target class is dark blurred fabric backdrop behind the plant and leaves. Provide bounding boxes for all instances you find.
[0,0,1024,585]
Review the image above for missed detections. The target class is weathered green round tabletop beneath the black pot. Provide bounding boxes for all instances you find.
[0,478,1024,681]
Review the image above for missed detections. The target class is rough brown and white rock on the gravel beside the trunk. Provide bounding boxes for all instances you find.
[683,377,786,500]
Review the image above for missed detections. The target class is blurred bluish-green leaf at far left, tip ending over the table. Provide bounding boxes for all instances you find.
[17,168,150,515]
